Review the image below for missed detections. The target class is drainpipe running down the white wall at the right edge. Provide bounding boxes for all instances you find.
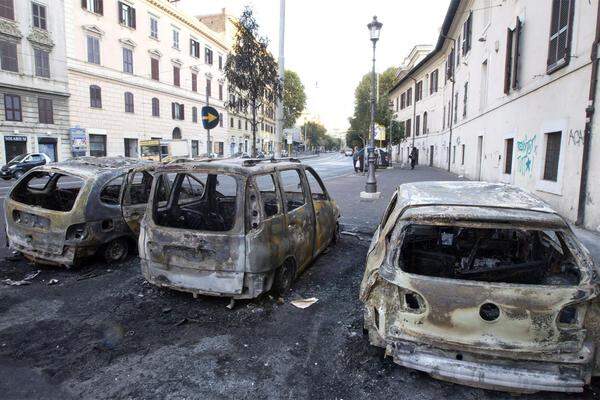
[575,5,600,225]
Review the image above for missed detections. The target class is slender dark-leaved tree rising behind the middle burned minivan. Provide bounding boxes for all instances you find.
[225,7,282,157]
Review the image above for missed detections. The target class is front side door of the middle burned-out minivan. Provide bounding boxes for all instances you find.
[305,167,337,255]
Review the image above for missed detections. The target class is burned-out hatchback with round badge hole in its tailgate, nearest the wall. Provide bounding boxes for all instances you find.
[360,182,600,392]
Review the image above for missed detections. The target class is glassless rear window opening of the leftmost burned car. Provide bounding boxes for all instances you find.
[11,171,85,211]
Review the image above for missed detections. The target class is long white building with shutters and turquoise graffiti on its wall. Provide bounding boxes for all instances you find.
[390,0,600,229]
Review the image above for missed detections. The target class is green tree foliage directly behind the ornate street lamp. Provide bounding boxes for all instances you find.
[346,67,397,147]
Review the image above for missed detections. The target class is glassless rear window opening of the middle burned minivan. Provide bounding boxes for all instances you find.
[153,173,237,232]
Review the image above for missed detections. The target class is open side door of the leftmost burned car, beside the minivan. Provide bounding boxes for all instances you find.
[121,169,153,235]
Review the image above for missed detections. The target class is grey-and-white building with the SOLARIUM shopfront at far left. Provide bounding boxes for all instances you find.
[0,0,70,164]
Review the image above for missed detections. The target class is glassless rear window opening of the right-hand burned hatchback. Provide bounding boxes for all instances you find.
[398,225,580,285]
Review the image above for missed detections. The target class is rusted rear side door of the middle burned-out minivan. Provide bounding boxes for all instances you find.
[279,168,315,271]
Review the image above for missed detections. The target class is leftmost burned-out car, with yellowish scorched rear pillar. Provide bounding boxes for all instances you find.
[4,157,152,267]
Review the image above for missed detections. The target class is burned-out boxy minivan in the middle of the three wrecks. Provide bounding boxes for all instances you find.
[123,159,339,298]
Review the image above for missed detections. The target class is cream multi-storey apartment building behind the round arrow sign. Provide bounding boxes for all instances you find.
[65,0,231,157]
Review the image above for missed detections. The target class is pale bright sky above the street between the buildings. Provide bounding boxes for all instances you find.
[178,0,450,133]
